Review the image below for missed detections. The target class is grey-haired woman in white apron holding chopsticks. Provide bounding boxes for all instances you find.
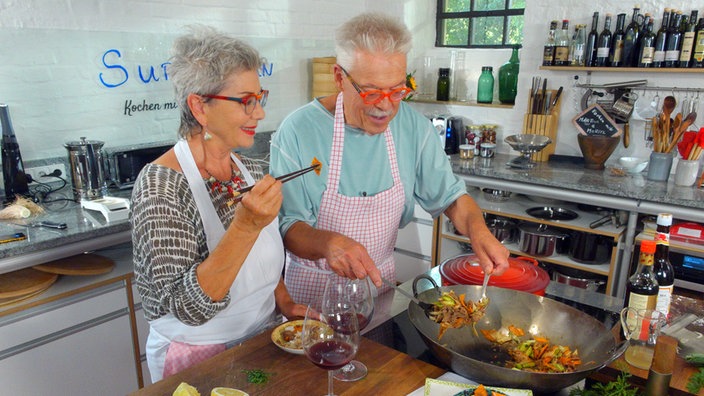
[130,26,306,382]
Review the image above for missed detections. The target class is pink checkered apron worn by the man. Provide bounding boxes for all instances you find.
[285,93,405,304]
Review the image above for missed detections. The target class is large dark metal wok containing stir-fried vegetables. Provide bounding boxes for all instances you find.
[408,278,627,393]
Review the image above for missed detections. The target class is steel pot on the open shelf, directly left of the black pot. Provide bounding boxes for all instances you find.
[518,222,570,257]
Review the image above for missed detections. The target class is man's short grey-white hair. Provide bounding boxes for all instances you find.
[335,13,412,69]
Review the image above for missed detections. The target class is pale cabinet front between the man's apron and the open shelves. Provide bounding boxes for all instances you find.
[393,205,434,282]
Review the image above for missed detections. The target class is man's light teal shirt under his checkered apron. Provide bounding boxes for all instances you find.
[269,99,466,235]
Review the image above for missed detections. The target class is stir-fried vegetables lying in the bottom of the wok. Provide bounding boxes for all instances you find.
[482,326,582,373]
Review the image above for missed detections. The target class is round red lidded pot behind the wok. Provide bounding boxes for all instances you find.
[439,254,550,293]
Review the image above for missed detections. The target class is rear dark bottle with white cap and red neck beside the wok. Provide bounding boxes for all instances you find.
[653,213,675,317]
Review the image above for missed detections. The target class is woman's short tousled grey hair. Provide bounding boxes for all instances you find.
[168,25,262,138]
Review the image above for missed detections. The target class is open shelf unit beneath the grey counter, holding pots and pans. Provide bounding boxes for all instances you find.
[435,186,625,295]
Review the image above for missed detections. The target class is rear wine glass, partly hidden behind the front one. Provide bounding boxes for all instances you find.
[333,278,374,381]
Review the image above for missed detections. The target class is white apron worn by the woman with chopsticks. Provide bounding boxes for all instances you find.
[146,140,284,382]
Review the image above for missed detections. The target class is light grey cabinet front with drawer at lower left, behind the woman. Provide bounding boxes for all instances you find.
[0,282,139,395]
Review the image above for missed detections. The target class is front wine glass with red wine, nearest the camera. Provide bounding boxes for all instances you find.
[301,276,359,396]
